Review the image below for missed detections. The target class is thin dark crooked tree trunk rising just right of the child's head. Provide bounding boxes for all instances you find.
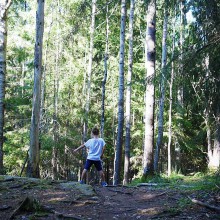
[100,2,109,138]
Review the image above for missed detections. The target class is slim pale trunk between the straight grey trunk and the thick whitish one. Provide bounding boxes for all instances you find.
[123,0,135,185]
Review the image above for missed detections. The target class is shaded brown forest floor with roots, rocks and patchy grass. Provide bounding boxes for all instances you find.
[0,176,220,220]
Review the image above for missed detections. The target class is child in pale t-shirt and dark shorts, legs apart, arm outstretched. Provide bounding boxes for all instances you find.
[73,128,107,186]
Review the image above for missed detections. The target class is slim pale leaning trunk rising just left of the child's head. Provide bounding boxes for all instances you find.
[83,0,96,142]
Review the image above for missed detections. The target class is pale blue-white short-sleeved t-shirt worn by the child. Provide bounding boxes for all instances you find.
[85,138,105,160]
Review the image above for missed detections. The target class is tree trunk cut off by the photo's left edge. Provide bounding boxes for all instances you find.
[0,0,11,174]
